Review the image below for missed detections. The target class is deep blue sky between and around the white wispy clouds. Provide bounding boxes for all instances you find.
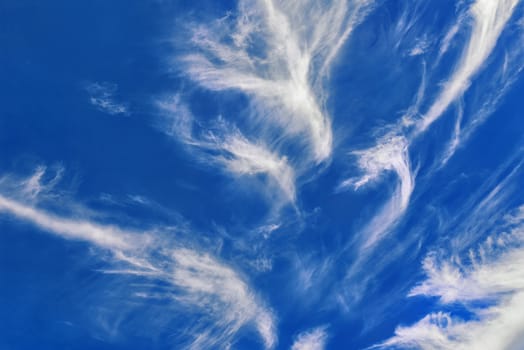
[0,0,524,350]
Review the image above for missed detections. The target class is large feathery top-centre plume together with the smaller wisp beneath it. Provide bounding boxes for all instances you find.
[159,0,373,213]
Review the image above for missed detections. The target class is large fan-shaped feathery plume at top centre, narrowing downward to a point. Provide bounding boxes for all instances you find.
[182,0,372,163]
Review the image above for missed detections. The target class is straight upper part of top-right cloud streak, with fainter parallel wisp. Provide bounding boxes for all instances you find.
[430,0,524,166]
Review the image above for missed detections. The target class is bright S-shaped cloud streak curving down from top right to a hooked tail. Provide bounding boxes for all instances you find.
[342,0,521,247]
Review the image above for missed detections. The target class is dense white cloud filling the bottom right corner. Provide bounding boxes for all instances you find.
[374,207,524,350]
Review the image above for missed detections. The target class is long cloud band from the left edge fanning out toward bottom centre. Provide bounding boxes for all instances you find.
[0,168,277,349]
